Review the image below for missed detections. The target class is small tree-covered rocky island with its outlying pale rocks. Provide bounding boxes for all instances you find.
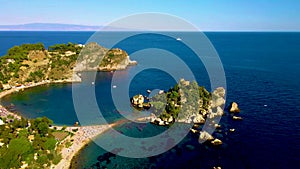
[132,79,242,146]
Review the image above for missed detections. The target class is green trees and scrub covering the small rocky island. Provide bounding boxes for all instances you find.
[150,80,211,119]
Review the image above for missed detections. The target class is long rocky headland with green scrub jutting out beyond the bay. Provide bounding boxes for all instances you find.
[0,43,136,86]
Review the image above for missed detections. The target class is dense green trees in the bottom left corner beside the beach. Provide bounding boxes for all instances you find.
[0,117,65,168]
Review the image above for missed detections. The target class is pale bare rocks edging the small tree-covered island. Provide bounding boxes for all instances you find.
[132,79,242,146]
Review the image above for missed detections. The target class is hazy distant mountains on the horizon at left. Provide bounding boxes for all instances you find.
[0,23,103,31]
